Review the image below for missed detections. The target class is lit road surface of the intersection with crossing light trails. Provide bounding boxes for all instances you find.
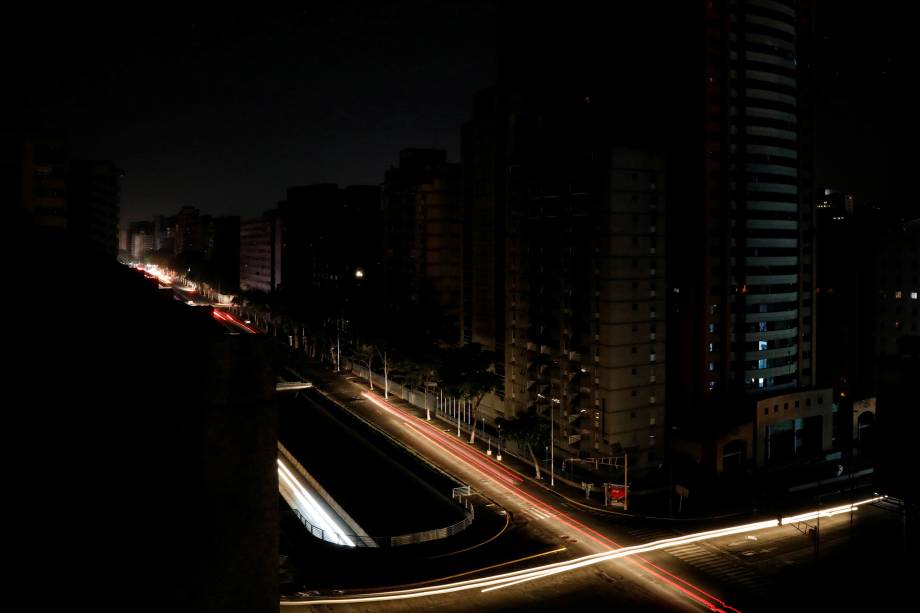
[285,370,904,611]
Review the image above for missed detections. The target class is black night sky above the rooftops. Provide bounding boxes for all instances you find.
[14,2,906,222]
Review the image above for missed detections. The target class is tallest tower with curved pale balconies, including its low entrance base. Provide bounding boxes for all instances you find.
[668,0,832,469]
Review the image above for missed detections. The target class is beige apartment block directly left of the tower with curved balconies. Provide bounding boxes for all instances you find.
[504,143,666,468]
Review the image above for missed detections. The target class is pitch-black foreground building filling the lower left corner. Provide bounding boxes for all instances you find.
[12,225,279,611]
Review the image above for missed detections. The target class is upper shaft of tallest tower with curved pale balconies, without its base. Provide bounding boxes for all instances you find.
[693,0,814,397]
